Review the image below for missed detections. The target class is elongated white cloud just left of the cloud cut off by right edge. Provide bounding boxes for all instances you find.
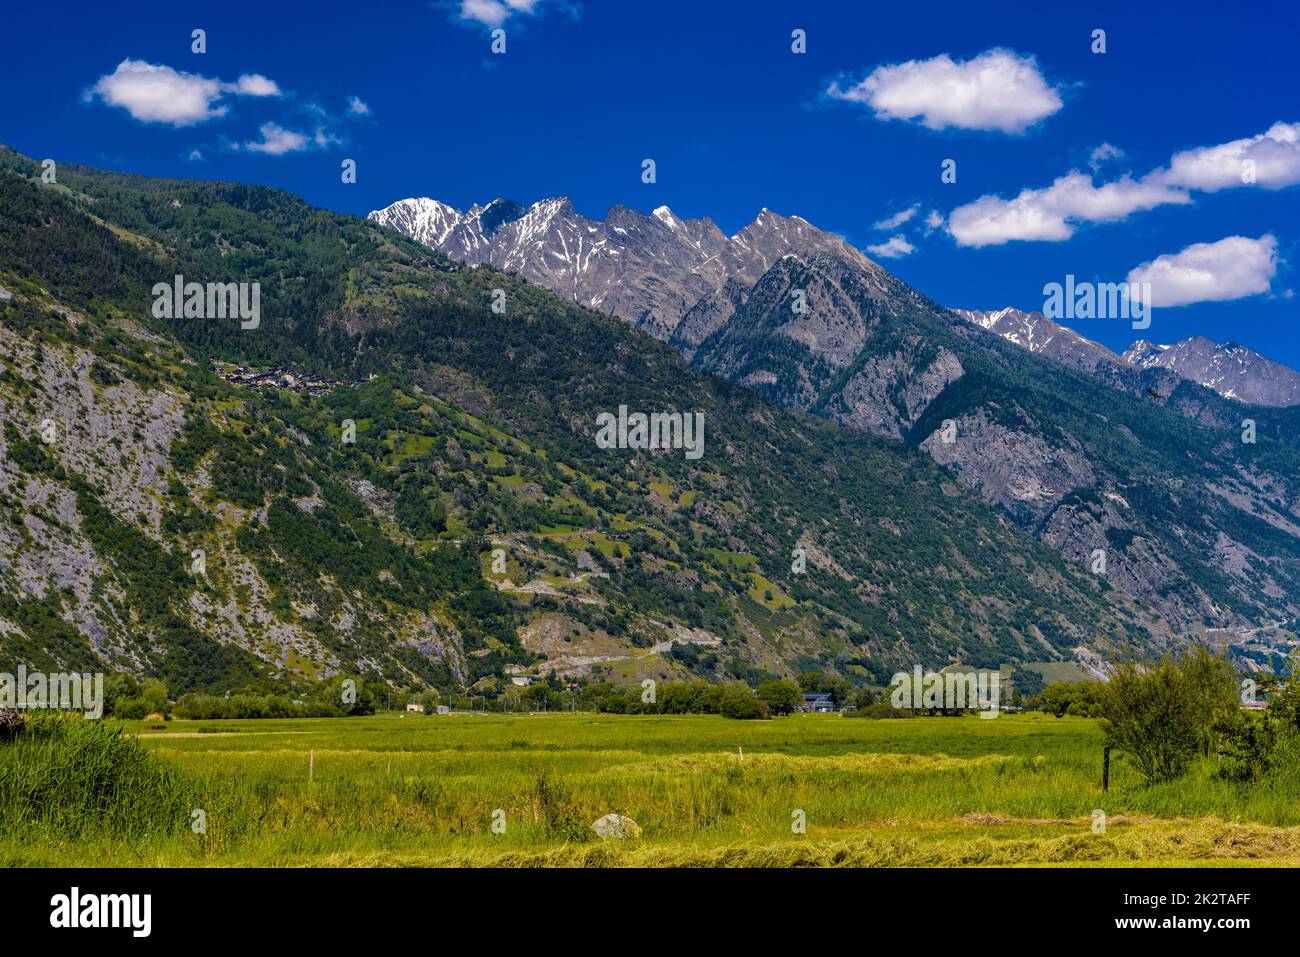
[948,172,1191,246]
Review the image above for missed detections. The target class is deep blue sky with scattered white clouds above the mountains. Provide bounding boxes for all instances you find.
[0,0,1300,367]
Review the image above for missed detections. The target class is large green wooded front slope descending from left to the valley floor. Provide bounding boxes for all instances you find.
[0,152,1175,689]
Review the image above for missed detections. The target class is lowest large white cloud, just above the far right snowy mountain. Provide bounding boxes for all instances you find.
[1128,234,1278,306]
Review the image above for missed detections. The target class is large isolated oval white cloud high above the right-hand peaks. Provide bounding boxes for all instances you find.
[827,49,1062,133]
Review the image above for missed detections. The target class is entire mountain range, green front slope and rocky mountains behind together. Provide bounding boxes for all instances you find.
[0,148,1300,693]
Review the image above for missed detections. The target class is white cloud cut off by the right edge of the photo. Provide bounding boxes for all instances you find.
[1153,124,1300,192]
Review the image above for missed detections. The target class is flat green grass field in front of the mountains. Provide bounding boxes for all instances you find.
[0,713,1300,866]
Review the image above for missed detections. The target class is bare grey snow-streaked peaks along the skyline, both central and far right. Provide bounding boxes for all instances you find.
[369,198,1300,407]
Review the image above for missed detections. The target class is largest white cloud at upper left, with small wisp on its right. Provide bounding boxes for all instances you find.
[85,59,281,126]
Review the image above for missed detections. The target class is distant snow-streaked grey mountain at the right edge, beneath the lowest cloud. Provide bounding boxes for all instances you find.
[1125,335,1300,406]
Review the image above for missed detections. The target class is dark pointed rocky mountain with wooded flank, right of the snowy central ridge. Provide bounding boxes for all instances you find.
[694,256,1300,627]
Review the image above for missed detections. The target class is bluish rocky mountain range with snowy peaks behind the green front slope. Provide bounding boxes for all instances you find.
[369,191,1300,639]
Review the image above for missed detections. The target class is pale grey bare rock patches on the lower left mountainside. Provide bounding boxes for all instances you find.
[0,289,468,677]
